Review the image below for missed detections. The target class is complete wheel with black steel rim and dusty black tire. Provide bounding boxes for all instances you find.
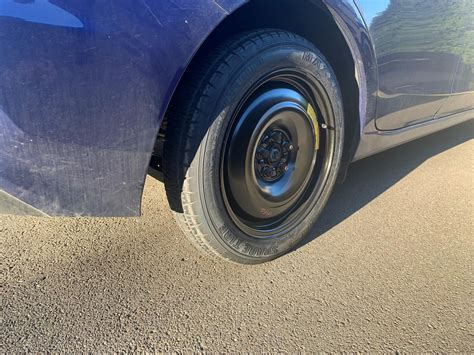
[164,30,343,264]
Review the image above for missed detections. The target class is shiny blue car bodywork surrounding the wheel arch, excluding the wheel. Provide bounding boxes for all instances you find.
[0,0,474,216]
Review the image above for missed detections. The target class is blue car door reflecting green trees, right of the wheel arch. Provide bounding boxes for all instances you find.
[355,0,466,130]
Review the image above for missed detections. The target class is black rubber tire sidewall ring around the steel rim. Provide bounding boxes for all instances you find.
[190,39,343,264]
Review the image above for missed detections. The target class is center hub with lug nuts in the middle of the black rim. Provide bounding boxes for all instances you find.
[255,128,293,182]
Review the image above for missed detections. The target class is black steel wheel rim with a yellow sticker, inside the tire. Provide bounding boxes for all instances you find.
[221,71,333,238]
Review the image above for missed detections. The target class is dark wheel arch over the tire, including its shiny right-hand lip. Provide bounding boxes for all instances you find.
[150,0,375,180]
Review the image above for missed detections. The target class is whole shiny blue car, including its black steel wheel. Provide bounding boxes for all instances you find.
[0,0,474,264]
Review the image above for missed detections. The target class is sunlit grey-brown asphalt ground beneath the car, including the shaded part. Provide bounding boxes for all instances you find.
[0,123,474,353]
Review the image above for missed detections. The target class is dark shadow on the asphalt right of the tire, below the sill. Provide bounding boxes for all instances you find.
[299,120,474,247]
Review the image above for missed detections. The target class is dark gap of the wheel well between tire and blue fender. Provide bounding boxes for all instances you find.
[150,0,359,182]
